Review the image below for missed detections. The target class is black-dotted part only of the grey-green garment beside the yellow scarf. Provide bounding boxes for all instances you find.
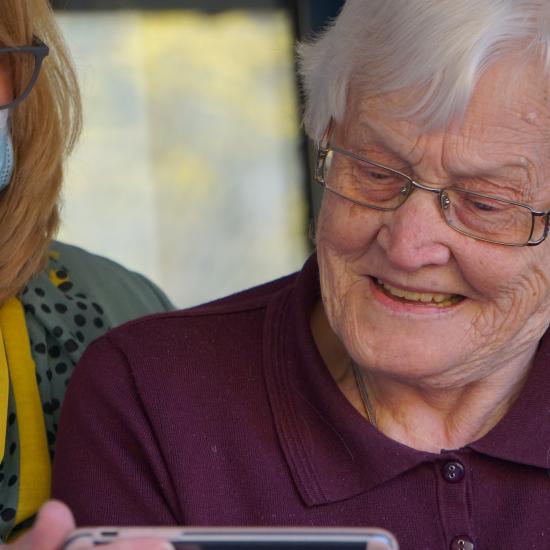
[0,254,112,540]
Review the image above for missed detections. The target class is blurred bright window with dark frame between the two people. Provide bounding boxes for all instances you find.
[53,0,343,307]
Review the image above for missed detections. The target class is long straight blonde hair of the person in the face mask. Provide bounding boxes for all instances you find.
[0,0,82,304]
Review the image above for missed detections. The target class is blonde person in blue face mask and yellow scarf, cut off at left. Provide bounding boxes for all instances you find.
[0,0,175,550]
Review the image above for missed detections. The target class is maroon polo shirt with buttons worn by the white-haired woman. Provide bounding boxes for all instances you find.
[53,258,550,550]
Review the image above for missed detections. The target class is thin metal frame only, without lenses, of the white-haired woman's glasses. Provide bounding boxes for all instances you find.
[315,143,550,247]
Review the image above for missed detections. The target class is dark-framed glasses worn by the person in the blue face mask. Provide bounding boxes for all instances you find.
[0,37,50,110]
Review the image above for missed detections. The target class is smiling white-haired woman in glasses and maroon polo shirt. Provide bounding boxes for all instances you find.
[50,0,550,550]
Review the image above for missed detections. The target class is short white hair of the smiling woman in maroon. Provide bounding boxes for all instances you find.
[298,0,550,141]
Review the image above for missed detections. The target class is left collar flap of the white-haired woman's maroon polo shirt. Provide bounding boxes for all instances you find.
[264,256,431,505]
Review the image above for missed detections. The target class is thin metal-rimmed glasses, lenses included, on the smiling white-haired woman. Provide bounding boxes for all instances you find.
[315,145,550,246]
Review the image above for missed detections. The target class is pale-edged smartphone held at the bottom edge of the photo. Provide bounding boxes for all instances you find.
[63,527,399,550]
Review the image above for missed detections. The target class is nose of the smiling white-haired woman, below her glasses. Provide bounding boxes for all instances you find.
[377,190,451,271]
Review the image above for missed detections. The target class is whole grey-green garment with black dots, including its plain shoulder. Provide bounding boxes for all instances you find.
[0,247,170,543]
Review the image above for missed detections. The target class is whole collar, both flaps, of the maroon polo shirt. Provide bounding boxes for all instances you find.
[264,255,550,506]
